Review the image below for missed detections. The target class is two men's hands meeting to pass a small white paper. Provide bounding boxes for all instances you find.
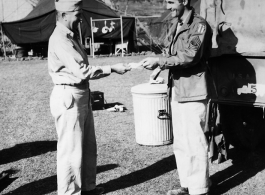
[111,57,159,74]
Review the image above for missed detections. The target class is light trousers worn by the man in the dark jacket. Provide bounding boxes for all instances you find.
[171,98,209,195]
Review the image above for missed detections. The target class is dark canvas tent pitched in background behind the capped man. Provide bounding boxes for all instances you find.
[2,0,136,54]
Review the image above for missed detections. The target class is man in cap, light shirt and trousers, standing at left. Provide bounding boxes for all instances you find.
[48,0,129,195]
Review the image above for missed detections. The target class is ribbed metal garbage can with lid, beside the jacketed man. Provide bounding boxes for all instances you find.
[131,83,173,146]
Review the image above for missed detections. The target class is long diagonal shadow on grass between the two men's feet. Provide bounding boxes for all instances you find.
[100,155,176,193]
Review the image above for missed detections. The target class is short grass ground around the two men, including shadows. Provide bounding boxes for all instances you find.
[0,56,265,195]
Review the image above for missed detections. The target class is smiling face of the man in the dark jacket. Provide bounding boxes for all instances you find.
[166,0,185,18]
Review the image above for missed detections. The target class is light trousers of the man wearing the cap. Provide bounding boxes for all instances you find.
[50,85,97,195]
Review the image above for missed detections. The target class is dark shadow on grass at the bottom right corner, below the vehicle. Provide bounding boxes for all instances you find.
[211,148,265,195]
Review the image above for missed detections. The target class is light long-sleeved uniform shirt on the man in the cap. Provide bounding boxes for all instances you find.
[48,22,111,85]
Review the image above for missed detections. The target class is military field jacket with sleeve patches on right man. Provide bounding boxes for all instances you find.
[159,9,212,102]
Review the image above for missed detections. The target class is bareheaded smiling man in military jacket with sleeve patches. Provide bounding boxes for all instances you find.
[141,0,212,195]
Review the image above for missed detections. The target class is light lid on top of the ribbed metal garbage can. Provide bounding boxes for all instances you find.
[131,83,167,94]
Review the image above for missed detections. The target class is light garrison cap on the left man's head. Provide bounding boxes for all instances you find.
[55,0,82,12]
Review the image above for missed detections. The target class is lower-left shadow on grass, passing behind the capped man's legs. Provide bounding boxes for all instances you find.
[0,164,118,195]
